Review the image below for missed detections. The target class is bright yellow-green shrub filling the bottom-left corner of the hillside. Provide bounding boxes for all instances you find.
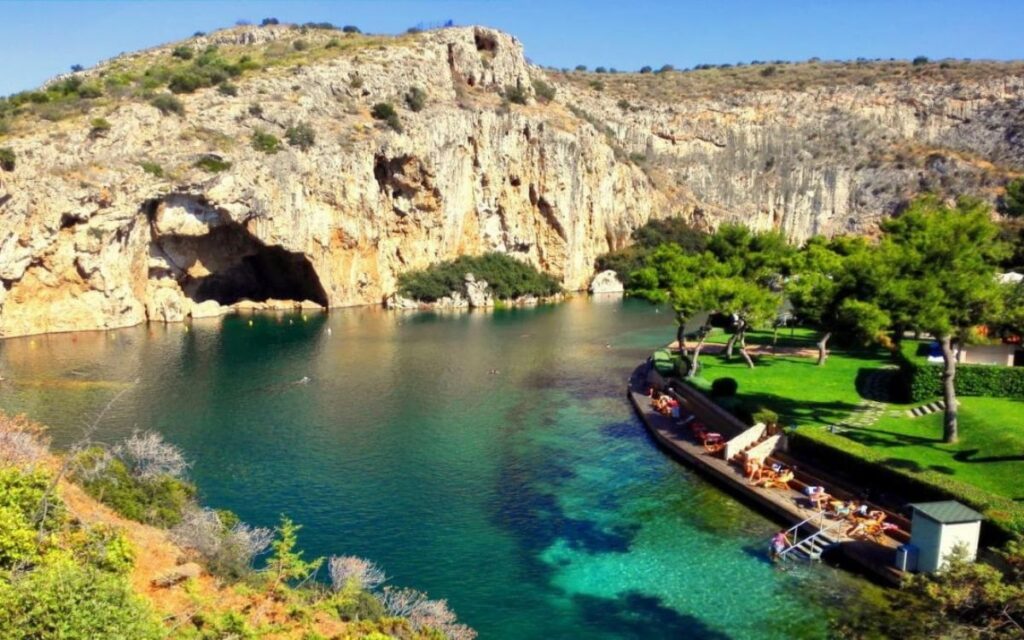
[0,556,166,640]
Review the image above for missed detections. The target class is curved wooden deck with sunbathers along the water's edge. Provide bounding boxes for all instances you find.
[629,367,906,584]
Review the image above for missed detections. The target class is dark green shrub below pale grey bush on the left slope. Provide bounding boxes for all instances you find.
[75,449,196,526]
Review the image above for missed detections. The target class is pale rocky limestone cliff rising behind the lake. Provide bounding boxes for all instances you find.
[0,27,1024,336]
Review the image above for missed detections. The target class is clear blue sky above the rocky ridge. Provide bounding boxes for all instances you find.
[0,0,1024,94]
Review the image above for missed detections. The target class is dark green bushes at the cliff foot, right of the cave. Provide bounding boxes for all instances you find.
[398,253,561,302]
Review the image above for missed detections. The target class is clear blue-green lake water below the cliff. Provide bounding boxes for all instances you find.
[0,299,865,639]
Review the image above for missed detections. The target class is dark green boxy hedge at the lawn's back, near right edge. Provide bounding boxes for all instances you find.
[899,353,1024,402]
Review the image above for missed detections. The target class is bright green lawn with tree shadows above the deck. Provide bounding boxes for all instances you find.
[679,330,1024,526]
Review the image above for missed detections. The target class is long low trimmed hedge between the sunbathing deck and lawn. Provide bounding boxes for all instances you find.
[788,429,1024,544]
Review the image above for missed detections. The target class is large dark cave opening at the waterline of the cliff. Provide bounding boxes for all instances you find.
[151,222,328,307]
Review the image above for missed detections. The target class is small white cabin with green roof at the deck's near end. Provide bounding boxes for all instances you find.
[910,500,982,573]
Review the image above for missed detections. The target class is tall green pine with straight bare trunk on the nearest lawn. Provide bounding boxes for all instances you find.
[878,196,1007,442]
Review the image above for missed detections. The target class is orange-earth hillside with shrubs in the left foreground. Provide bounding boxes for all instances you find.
[0,415,476,640]
